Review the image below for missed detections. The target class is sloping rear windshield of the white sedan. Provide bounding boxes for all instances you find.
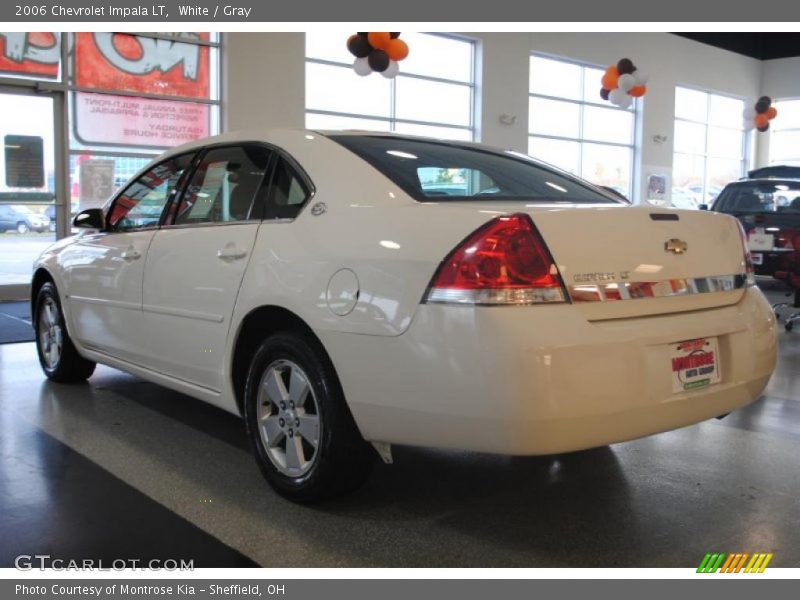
[331,135,625,204]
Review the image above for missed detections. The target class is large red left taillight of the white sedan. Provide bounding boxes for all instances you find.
[425,214,567,305]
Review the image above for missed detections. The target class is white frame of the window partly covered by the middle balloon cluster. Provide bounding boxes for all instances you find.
[527,52,641,197]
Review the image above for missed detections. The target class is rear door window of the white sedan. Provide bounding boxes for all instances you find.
[175,146,271,225]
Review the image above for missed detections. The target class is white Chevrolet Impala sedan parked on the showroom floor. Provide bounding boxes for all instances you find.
[32,130,776,501]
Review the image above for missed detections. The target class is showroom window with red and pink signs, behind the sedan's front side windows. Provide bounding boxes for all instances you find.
[69,33,220,212]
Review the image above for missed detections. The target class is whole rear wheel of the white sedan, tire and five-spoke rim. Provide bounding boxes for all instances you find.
[244,332,373,503]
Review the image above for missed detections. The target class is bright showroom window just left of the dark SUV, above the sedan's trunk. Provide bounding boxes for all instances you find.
[672,87,747,208]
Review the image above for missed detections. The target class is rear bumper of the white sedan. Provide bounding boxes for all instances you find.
[318,288,777,455]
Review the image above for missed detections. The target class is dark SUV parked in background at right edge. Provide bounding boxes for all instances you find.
[701,166,800,276]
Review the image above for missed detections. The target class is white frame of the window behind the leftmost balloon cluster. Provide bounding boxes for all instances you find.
[303,32,478,142]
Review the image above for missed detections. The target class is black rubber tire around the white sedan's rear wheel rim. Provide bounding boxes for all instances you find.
[244,331,375,504]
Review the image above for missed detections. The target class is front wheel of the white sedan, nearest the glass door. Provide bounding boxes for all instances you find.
[33,282,96,383]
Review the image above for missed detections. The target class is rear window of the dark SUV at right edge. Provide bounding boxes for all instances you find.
[714,180,800,214]
